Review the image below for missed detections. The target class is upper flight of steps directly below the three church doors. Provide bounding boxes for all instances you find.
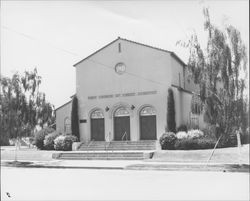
[78,140,157,151]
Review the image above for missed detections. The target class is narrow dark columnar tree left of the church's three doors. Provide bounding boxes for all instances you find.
[71,96,80,140]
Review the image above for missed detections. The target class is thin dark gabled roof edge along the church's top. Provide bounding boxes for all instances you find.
[73,37,186,67]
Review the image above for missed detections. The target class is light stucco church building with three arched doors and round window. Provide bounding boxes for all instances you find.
[56,37,203,142]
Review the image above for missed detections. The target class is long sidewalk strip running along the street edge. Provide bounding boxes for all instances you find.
[1,160,249,173]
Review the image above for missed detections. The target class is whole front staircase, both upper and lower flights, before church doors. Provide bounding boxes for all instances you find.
[52,140,157,160]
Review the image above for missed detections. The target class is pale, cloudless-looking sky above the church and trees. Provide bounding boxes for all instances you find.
[1,0,249,108]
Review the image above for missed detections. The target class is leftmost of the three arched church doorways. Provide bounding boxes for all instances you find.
[90,109,105,141]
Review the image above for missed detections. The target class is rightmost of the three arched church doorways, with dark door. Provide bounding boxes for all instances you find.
[139,106,156,140]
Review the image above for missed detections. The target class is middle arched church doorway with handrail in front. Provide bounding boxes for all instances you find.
[114,107,130,141]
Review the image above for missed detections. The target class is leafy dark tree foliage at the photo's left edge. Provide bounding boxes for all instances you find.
[0,69,54,139]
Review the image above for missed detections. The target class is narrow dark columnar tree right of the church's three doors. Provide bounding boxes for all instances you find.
[167,88,176,132]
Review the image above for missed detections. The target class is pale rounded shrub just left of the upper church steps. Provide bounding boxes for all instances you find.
[54,135,77,151]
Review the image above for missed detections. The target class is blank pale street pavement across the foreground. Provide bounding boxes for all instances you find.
[1,167,249,201]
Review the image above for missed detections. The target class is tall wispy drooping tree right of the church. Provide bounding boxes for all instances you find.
[179,8,247,140]
